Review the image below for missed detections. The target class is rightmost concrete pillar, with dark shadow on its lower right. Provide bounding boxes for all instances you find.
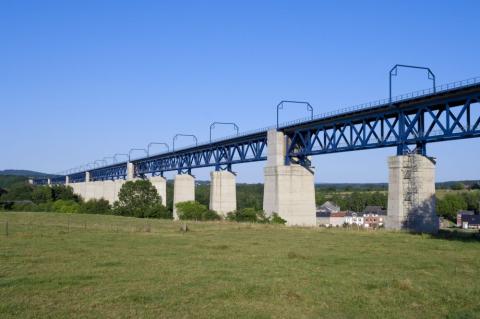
[385,154,439,233]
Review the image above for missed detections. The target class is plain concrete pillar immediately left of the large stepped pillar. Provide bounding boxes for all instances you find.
[210,171,237,216]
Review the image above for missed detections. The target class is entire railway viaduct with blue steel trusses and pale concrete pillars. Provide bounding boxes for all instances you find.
[32,65,480,233]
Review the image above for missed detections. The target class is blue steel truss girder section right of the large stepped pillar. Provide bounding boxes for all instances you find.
[286,93,480,158]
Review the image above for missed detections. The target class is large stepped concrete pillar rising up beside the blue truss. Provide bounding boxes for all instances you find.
[263,129,316,226]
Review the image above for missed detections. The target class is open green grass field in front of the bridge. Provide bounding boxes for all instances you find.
[0,213,480,318]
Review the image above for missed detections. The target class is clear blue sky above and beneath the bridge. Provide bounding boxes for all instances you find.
[0,0,480,182]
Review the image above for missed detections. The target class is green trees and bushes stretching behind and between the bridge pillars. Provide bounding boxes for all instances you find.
[0,180,480,222]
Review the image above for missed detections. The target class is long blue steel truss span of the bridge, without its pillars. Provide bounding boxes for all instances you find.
[38,78,480,184]
